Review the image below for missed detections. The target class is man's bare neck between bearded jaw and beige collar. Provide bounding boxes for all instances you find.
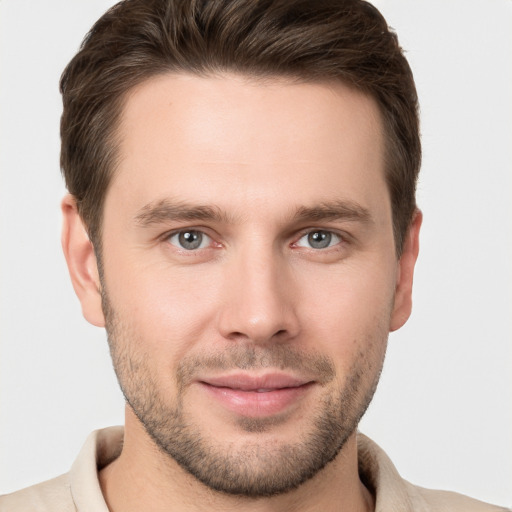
[99,410,374,512]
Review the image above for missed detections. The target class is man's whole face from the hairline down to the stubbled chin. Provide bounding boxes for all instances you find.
[63,75,420,496]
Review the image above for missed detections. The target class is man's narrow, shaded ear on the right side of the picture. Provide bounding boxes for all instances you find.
[389,210,423,331]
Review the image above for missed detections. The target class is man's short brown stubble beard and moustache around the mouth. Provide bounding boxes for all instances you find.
[103,292,387,498]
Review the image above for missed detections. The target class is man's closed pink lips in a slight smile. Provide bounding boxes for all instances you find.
[198,373,314,418]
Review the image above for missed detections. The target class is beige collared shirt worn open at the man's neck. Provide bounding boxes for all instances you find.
[0,427,510,512]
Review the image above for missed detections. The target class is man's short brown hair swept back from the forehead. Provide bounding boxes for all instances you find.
[60,0,421,255]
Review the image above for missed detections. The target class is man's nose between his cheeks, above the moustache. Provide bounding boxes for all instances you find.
[219,247,300,344]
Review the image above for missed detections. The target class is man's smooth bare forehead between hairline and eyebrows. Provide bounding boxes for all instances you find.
[106,74,387,222]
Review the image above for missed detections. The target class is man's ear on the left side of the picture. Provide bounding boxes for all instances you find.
[61,194,105,327]
